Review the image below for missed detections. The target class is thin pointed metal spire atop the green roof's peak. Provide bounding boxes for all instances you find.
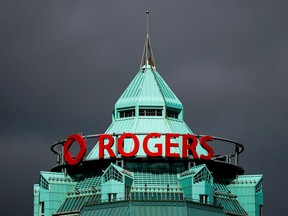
[140,11,156,69]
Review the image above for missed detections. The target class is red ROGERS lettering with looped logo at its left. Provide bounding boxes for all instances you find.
[64,133,214,165]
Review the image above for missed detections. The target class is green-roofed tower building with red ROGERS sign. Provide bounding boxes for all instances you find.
[34,30,263,216]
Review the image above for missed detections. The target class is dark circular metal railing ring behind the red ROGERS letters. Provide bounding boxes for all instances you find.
[51,133,244,165]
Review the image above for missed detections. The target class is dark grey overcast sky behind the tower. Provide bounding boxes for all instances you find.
[0,0,288,216]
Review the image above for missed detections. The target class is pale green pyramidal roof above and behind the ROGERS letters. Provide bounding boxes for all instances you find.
[87,34,206,160]
